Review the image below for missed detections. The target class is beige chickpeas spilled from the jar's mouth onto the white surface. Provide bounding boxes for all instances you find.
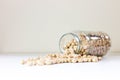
[21,40,102,66]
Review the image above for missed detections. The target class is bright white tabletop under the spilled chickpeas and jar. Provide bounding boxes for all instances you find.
[0,53,120,80]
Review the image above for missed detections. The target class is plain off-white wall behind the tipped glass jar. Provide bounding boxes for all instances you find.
[0,0,120,52]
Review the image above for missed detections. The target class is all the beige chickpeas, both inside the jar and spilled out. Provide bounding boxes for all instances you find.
[21,32,111,66]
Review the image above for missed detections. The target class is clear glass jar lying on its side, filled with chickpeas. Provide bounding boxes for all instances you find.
[59,31,111,56]
